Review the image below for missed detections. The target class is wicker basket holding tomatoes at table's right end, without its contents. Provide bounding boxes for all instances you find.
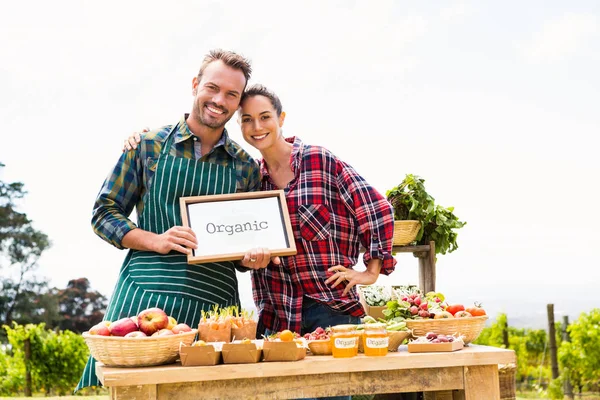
[406,315,488,344]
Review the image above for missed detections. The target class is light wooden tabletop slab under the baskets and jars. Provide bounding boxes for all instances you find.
[96,345,515,387]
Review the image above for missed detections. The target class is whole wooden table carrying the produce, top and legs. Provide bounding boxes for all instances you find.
[96,345,515,400]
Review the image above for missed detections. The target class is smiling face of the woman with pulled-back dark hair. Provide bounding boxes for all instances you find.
[239,95,285,150]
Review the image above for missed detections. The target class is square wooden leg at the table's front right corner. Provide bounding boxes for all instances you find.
[454,365,500,400]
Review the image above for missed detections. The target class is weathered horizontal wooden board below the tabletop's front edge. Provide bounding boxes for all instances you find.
[157,367,463,400]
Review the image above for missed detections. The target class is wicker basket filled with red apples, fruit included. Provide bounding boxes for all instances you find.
[82,307,198,367]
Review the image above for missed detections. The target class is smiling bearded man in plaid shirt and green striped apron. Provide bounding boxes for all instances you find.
[75,50,270,391]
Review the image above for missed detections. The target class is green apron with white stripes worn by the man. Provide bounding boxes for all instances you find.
[75,125,240,391]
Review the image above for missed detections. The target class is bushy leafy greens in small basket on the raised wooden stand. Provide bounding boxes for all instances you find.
[386,174,466,254]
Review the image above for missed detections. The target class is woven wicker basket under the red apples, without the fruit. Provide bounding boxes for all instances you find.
[82,329,198,367]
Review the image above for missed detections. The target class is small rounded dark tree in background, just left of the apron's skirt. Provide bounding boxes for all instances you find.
[58,278,106,333]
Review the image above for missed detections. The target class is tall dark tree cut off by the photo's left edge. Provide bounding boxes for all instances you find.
[0,163,50,324]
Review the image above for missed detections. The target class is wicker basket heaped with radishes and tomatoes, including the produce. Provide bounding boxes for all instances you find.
[383,290,488,344]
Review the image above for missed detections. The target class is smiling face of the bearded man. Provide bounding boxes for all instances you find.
[192,60,246,129]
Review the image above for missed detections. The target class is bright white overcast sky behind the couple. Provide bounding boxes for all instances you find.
[0,0,600,328]
